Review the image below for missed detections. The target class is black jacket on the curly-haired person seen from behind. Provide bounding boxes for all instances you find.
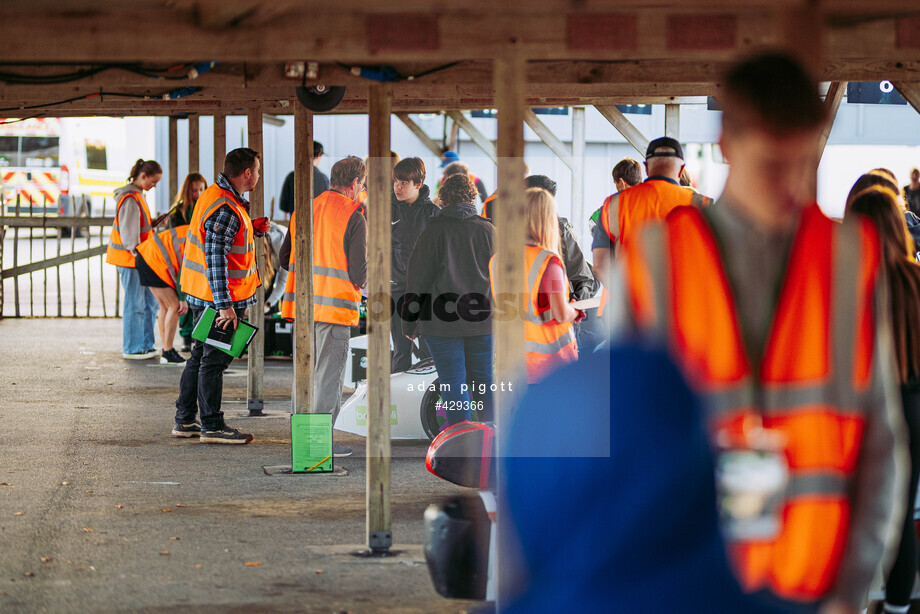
[401,204,495,337]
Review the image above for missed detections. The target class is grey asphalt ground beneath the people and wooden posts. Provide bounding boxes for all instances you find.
[0,319,477,613]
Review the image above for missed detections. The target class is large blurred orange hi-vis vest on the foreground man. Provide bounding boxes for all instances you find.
[624,205,880,601]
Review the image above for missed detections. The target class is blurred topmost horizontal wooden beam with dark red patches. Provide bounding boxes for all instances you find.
[10,0,920,64]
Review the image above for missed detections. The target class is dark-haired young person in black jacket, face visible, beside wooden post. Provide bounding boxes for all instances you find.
[390,158,438,373]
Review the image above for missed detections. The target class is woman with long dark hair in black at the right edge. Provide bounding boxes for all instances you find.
[846,183,920,613]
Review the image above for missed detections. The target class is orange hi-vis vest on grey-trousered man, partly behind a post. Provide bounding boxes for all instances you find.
[281,190,361,326]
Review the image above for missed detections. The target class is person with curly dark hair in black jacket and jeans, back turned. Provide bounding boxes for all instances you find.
[402,174,495,425]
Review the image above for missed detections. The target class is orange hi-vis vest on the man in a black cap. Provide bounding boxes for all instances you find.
[601,179,708,250]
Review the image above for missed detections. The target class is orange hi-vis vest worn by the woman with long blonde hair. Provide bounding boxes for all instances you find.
[489,245,578,384]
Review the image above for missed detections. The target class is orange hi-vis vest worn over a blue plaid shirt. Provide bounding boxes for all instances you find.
[181,184,261,303]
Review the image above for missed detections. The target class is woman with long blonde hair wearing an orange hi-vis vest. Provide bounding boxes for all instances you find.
[489,188,585,383]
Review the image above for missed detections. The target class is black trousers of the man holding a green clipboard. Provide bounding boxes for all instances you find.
[176,307,244,431]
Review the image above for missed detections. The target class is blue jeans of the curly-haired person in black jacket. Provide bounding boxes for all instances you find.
[422,335,492,425]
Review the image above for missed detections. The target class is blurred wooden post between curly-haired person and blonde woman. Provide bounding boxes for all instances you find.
[496,56,527,599]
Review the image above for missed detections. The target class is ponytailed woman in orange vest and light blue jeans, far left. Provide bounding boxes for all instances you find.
[105,159,163,360]
